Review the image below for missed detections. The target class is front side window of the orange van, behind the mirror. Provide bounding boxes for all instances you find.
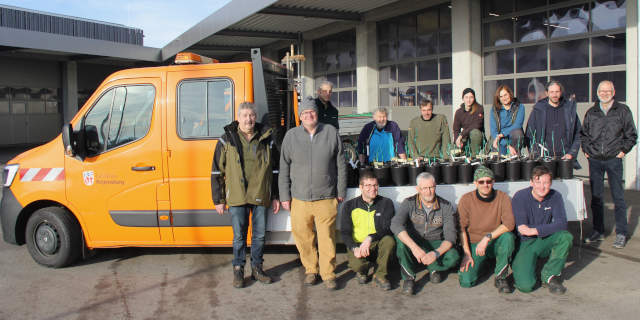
[84,85,156,155]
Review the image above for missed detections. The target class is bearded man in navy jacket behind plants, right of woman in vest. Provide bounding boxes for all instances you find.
[526,80,580,169]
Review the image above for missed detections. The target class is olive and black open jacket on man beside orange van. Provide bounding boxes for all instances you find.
[211,121,278,207]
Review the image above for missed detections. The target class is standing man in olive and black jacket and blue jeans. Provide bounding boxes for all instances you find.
[211,102,280,288]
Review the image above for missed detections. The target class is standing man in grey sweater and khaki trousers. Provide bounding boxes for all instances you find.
[278,99,347,290]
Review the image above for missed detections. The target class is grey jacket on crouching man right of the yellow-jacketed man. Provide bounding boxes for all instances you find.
[391,194,457,244]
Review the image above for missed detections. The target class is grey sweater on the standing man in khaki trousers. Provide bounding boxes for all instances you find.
[278,123,347,201]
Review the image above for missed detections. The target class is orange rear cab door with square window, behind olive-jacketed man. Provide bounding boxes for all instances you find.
[167,64,245,245]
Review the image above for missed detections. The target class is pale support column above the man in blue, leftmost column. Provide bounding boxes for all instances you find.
[356,22,379,113]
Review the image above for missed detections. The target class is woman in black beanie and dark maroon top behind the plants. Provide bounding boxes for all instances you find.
[453,88,484,155]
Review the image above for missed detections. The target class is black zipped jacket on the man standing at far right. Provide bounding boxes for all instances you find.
[580,100,638,160]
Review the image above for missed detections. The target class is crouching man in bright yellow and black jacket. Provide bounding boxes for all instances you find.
[340,171,395,290]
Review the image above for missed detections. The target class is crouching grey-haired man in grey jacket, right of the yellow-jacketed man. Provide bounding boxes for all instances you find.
[391,172,460,295]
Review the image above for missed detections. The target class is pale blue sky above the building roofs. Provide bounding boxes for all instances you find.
[0,0,230,48]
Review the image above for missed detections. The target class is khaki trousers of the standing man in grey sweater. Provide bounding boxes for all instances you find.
[291,198,338,281]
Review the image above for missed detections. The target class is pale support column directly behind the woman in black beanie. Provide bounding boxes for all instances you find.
[450,0,483,114]
